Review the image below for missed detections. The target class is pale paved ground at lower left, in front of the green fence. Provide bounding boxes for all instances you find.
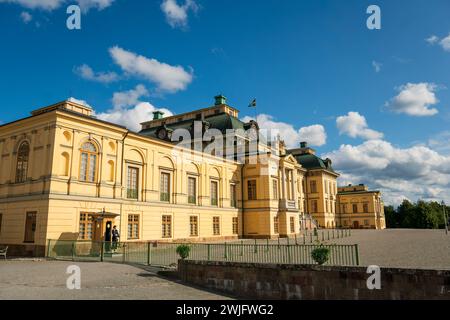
[0,260,232,300]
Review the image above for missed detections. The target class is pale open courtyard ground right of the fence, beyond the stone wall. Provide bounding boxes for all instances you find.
[327,229,450,269]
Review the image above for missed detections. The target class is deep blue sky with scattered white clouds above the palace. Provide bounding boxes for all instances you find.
[0,0,450,203]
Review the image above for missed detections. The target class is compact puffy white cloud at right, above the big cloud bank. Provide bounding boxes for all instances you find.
[386,82,439,117]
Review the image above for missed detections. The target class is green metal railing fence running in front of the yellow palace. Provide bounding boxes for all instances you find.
[47,240,359,267]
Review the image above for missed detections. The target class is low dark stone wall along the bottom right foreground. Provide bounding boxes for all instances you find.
[178,260,450,300]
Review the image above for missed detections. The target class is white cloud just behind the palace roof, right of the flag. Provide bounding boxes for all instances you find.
[242,114,327,148]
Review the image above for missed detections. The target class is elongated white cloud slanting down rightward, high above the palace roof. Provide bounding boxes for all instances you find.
[109,46,193,92]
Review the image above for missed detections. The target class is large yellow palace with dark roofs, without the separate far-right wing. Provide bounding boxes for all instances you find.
[0,96,386,255]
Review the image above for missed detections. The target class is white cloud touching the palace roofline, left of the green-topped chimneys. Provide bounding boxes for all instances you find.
[96,102,172,132]
